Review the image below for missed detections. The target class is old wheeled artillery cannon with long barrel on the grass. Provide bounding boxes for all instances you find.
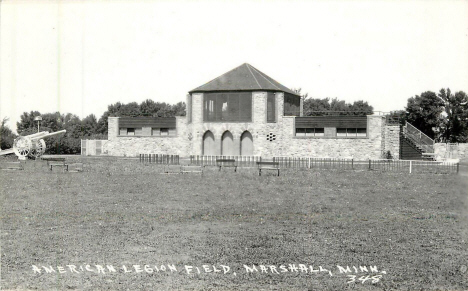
[0,129,67,159]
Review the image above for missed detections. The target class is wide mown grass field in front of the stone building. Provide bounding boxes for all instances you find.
[0,158,468,290]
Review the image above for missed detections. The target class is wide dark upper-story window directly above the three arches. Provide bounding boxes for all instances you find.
[203,92,252,122]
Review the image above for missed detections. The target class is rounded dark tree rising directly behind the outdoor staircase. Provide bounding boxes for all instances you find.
[406,91,444,139]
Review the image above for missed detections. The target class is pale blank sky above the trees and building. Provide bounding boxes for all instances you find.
[0,0,468,130]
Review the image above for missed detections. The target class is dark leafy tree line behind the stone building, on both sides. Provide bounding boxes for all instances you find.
[0,89,468,154]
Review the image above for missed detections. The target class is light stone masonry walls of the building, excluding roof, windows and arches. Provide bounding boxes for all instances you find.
[105,92,399,160]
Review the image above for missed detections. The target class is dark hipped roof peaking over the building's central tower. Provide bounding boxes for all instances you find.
[189,63,297,95]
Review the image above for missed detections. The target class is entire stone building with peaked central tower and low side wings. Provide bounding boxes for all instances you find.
[104,64,400,160]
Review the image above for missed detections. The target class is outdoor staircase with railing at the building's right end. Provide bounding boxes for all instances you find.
[400,122,434,160]
